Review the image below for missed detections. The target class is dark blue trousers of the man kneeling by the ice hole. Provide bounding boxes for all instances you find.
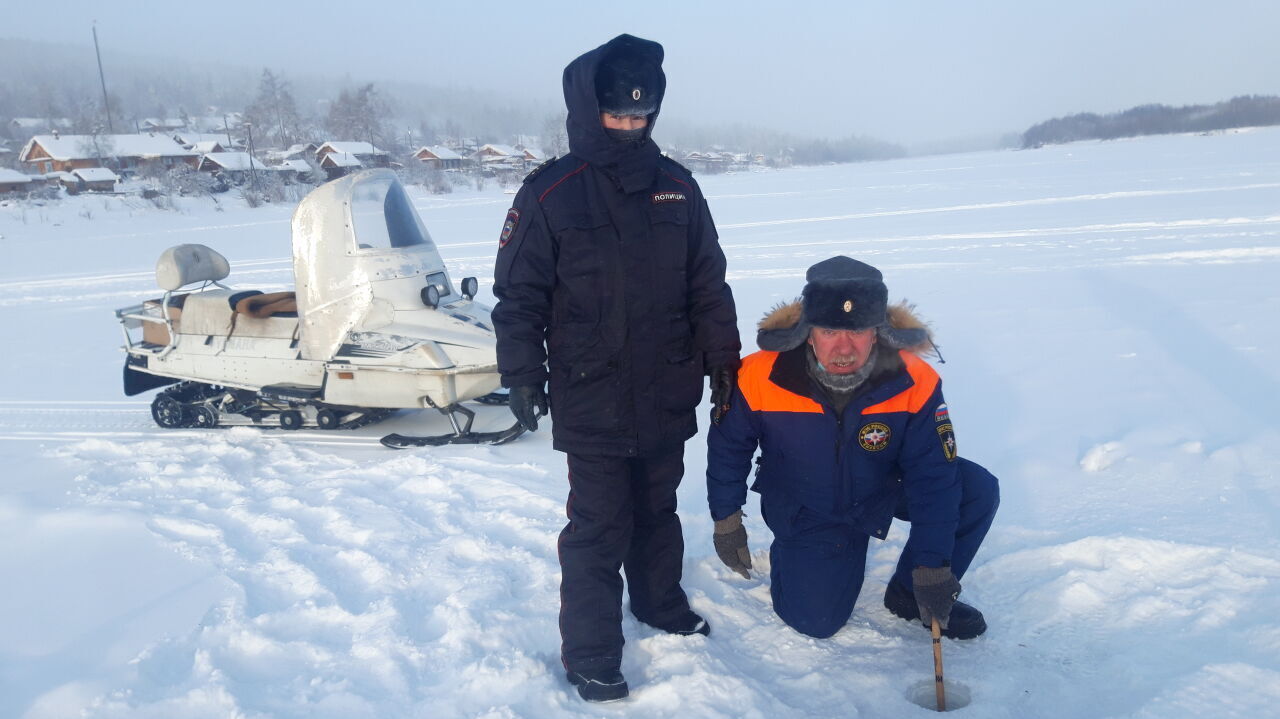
[760,458,1000,638]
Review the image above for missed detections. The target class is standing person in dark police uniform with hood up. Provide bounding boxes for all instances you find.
[493,35,741,701]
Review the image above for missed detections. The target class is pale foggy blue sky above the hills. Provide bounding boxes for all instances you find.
[0,0,1280,143]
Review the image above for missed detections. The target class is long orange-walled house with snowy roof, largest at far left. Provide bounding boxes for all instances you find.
[18,133,200,174]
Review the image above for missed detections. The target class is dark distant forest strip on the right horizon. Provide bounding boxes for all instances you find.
[1023,95,1280,148]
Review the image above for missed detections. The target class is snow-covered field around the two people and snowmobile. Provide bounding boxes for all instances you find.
[0,128,1280,719]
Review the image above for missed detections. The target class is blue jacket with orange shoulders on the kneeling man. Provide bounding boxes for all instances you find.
[707,344,960,567]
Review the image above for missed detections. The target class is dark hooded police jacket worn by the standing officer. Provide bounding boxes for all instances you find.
[493,36,741,457]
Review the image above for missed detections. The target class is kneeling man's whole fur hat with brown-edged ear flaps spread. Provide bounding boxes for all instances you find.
[755,255,932,352]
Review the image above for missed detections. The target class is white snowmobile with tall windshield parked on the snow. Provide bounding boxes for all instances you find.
[115,170,524,448]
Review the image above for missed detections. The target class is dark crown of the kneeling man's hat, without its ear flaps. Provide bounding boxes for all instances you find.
[801,255,888,330]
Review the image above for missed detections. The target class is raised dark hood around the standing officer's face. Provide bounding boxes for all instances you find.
[563,35,667,193]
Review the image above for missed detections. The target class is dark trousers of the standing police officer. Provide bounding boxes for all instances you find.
[558,444,689,672]
